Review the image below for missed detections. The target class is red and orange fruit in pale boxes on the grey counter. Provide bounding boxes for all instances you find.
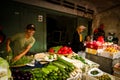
[85,41,120,59]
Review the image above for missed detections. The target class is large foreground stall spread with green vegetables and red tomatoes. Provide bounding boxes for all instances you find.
[7,46,119,80]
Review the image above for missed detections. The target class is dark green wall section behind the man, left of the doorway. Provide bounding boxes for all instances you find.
[0,1,46,52]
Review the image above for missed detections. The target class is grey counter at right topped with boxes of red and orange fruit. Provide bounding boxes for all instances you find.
[86,42,120,74]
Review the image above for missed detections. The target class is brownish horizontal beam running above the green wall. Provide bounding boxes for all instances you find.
[14,0,96,19]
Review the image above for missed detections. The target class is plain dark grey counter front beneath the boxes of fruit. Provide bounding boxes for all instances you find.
[86,53,120,74]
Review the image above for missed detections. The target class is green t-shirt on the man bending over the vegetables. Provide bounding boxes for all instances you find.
[11,33,35,57]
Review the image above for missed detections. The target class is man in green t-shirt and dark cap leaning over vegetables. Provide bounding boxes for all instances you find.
[6,24,35,62]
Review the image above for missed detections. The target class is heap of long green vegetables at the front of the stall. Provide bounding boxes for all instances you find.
[11,57,77,80]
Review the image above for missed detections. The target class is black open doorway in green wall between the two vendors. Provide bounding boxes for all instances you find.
[46,14,77,49]
